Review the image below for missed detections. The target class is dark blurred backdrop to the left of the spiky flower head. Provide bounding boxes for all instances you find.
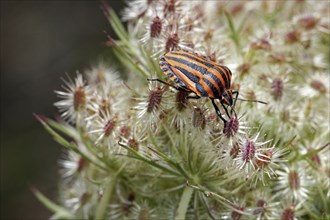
[0,0,124,219]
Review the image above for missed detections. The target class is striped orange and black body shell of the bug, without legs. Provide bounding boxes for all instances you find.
[160,51,231,98]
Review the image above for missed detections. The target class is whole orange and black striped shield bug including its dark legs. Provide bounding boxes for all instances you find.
[148,50,238,124]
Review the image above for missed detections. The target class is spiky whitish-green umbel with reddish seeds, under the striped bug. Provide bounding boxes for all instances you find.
[33,0,330,220]
